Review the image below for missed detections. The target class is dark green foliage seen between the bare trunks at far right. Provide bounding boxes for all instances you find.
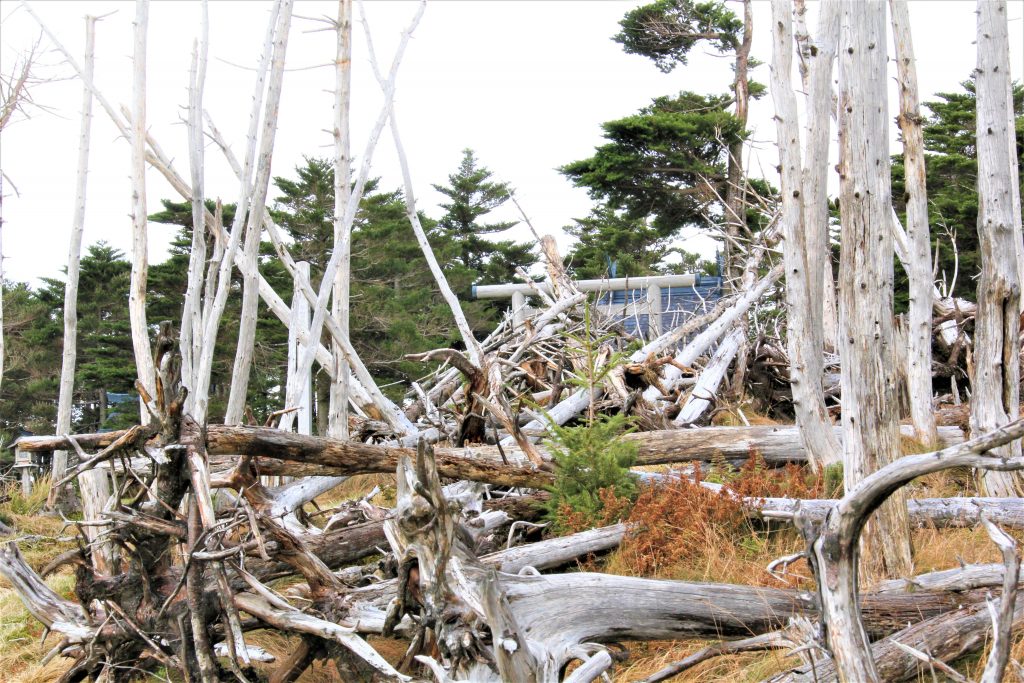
[892,81,1024,311]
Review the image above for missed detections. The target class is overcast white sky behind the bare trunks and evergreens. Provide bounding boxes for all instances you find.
[0,0,1024,284]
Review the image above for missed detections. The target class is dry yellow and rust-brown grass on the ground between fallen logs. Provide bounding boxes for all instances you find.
[0,450,1024,683]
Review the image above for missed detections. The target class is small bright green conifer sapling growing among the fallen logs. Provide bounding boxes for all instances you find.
[547,414,637,532]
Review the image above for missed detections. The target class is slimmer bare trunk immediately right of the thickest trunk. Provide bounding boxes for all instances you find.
[889,0,936,445]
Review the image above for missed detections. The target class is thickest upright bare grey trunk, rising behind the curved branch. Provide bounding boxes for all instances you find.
[839,0,912,577]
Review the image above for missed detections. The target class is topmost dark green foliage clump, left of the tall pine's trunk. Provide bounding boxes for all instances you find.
[613,0,743,74]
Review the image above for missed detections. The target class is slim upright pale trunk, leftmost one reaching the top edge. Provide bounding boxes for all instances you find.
[129,0,157,424]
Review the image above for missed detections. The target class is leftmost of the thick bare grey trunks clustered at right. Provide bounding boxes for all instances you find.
[771,0,840,470]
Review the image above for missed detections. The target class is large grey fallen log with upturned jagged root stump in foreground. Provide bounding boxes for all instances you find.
[323,444,1011,680]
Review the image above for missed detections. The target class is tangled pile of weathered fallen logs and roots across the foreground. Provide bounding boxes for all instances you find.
[6,294,1024,682]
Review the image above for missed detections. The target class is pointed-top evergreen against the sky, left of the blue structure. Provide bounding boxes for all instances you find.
[434,150,534,291]
